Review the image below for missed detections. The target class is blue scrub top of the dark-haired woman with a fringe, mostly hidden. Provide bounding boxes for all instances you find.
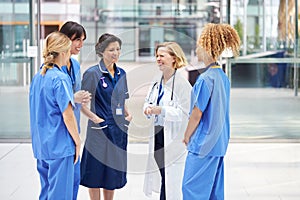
[61,57,81,133]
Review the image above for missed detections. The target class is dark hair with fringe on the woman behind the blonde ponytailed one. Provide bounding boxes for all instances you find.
[59,21,86,40]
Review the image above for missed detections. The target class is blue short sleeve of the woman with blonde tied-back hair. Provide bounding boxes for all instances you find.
[54,79,74,113]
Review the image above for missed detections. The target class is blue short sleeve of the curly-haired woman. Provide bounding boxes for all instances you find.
[192,79,211,112]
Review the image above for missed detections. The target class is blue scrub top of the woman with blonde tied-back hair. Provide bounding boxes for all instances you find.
[29,67,75,159]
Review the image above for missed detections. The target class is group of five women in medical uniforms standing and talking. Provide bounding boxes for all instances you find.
[30,22,239,200]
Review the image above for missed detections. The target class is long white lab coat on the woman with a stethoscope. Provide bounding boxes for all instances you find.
[144,69,192,200]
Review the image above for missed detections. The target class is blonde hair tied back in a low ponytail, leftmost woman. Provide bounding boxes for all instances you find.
[41,31,72,75]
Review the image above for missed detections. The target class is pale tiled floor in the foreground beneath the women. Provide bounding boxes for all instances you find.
[0,143,300,200]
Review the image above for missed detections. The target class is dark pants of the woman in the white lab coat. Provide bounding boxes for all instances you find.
[154,126,166,200]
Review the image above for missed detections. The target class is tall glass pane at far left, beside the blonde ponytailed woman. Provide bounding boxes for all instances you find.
[0,0,32,139]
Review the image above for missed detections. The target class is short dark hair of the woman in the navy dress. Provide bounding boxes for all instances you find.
[95,33,122,57]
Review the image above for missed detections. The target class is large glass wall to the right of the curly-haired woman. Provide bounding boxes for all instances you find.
[222,0,300,141]
